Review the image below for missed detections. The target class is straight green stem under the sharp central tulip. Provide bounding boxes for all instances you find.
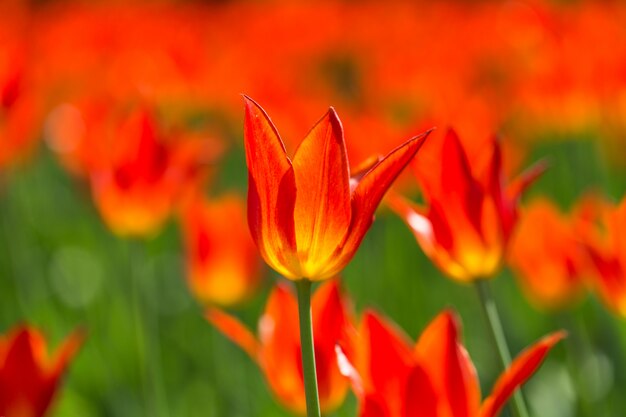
[296,279,321,417]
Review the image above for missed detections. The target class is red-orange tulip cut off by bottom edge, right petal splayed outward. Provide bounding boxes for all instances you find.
[337,311,565,417]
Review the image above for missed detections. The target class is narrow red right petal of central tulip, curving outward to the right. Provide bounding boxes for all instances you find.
[327,130,432,276]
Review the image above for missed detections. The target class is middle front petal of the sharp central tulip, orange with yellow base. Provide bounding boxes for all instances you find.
[293,108,351,278]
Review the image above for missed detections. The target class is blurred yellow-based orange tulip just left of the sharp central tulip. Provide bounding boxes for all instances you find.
[182,195,262,305]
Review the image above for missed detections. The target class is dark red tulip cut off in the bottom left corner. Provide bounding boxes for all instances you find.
[0,326,84,417]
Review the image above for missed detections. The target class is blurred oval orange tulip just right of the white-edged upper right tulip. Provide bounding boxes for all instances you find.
[508,199,587,308]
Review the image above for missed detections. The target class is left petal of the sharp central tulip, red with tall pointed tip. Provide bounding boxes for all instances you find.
[244,97,301,278]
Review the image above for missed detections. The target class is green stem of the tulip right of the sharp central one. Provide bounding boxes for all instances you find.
[475,279,528,417]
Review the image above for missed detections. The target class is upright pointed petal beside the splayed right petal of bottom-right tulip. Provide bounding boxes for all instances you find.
[415,311,480,417]
